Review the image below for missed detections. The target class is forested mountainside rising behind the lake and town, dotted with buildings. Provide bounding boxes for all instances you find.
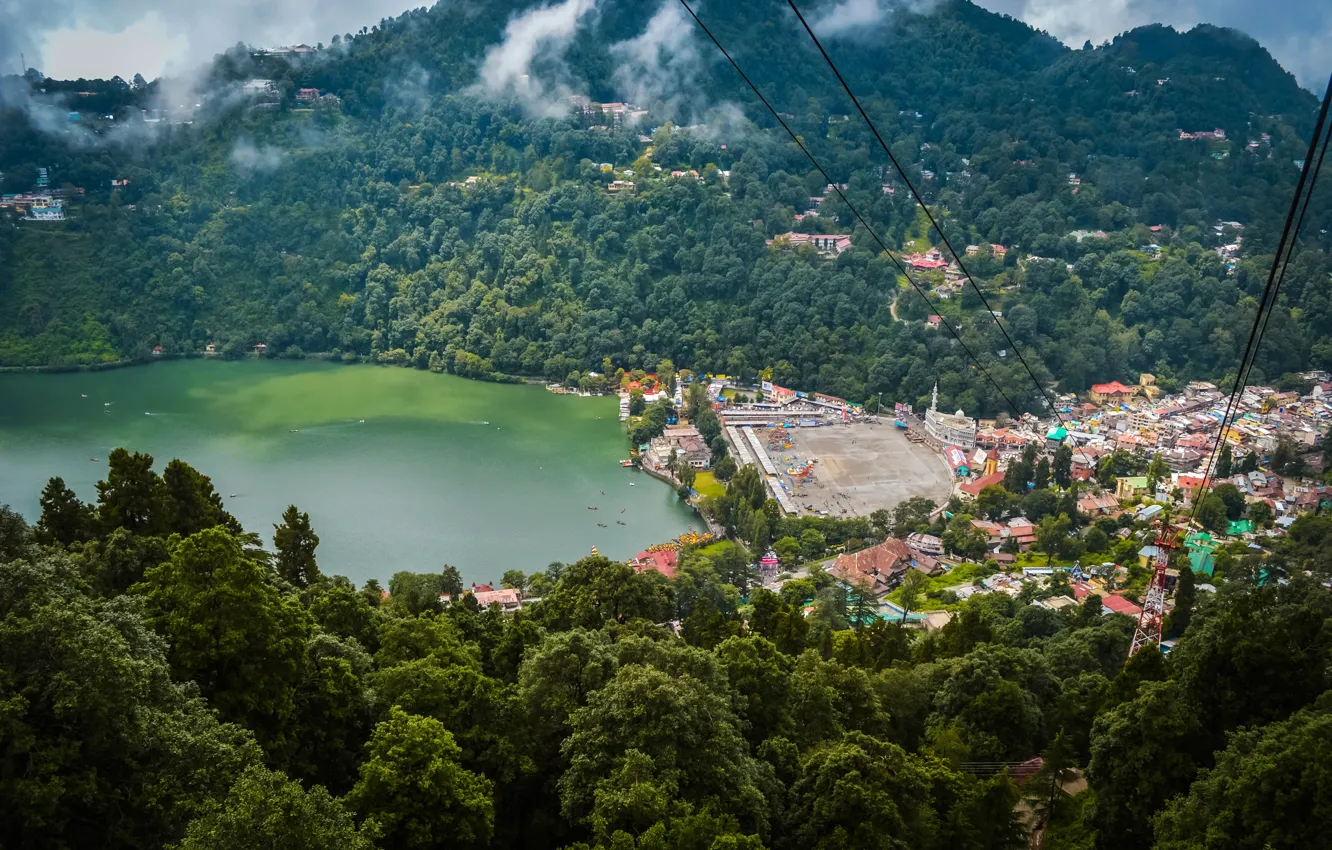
[0,0,1332,414]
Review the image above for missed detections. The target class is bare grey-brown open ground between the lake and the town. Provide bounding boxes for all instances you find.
[761,421,952,516]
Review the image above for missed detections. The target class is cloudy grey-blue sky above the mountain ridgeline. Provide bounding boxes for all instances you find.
[0,0,1332,88]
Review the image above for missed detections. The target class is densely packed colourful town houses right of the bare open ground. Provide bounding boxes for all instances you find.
[827,372,1332,616]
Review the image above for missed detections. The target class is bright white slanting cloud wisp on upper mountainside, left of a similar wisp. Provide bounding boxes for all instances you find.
[473,0,597,117]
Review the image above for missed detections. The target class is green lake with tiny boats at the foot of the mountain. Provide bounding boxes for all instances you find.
[0,360,703,584]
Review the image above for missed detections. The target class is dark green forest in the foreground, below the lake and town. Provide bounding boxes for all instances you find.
[0,449,1332,850]
